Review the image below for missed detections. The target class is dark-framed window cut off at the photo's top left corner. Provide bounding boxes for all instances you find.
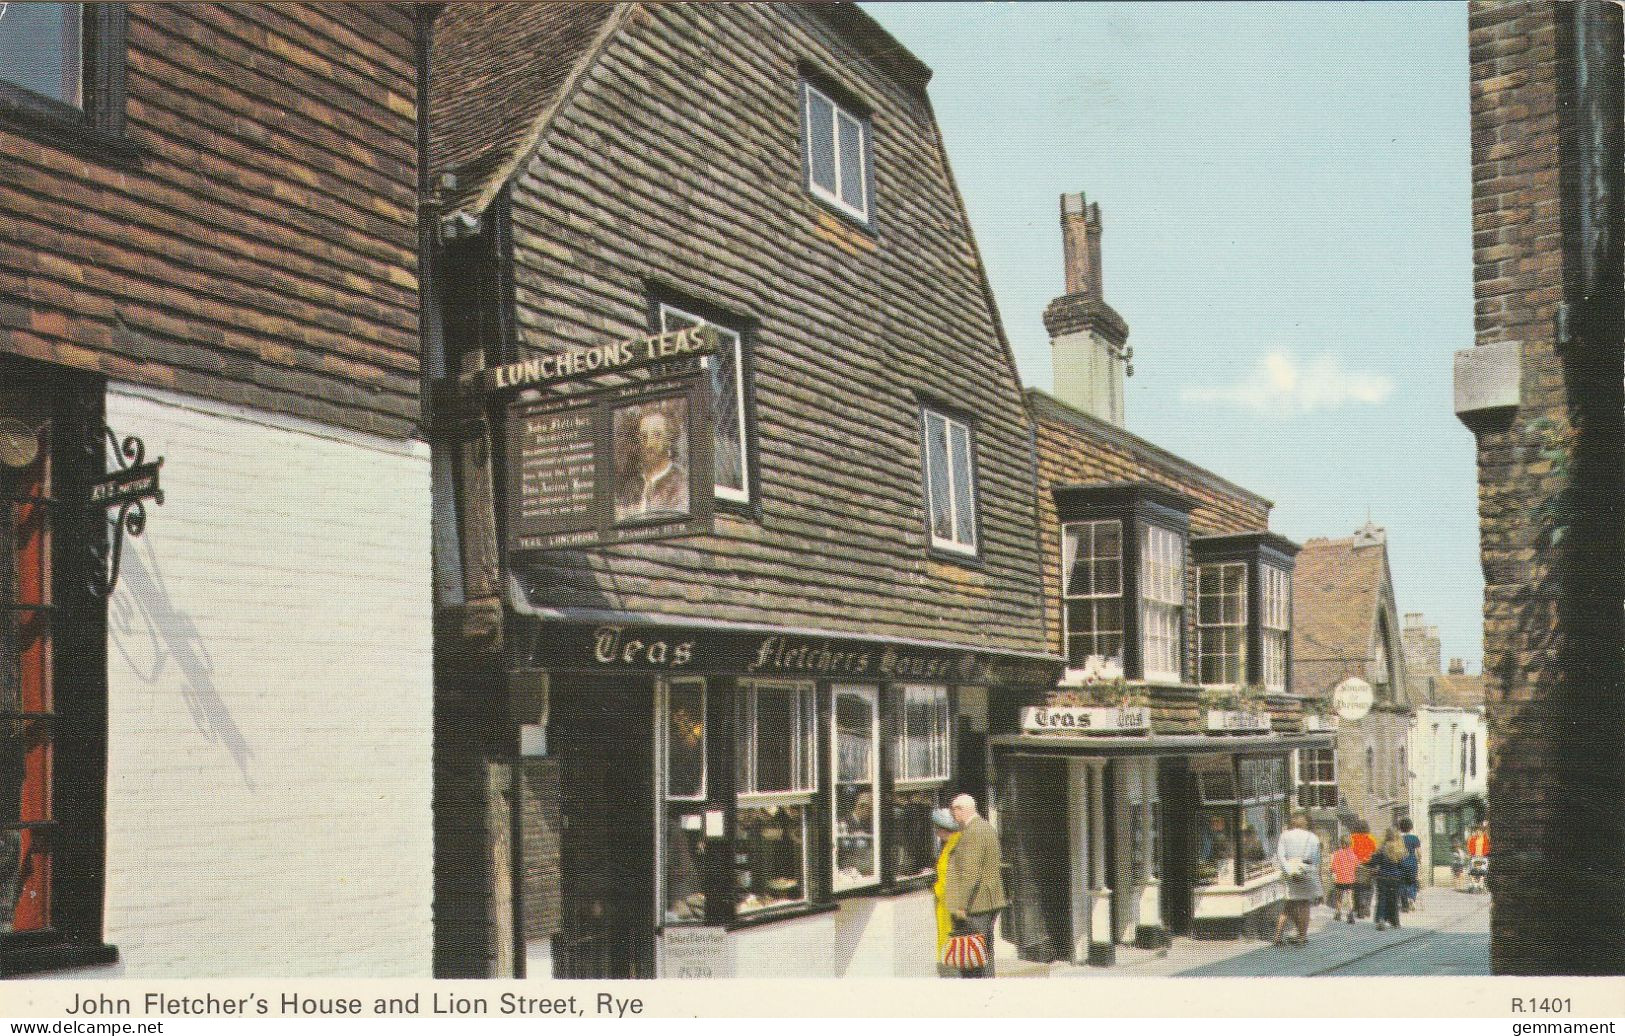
[0,3,132,158]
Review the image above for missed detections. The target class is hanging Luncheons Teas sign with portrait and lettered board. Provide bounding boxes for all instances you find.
[497,328,715,552]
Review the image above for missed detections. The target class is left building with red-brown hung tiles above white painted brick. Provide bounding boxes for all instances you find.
[0,3,432,978]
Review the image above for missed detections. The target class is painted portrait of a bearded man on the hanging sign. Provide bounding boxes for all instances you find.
[614,396,689,523]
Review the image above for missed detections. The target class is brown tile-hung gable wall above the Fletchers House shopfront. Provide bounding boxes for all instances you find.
[500,5,1043,650]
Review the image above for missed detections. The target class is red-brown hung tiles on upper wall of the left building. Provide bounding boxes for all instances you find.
[0,3,419,435]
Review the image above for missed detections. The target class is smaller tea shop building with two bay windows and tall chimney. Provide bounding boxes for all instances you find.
[991,195,1329,965]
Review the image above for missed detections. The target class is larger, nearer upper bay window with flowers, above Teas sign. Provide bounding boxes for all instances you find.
[1055,482,1190,684]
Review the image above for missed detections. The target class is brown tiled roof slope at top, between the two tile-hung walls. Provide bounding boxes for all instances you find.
[429,2,624,213]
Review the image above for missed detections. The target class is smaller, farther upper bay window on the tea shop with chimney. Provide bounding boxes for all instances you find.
[1191,533,1298,693]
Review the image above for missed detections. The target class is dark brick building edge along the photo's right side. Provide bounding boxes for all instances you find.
[1456,2,1625,974]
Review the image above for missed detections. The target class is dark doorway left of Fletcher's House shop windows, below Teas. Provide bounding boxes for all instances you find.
[548,680,655,979]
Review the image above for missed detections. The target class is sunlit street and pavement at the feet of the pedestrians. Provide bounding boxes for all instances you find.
[999,887,1490,978]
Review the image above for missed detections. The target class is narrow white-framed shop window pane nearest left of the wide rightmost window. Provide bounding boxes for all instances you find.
[830,684,881,891]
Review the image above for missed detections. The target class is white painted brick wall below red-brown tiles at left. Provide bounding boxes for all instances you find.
[88,386,434,978]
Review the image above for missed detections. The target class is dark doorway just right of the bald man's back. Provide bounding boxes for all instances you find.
[999,757,1073,961]
